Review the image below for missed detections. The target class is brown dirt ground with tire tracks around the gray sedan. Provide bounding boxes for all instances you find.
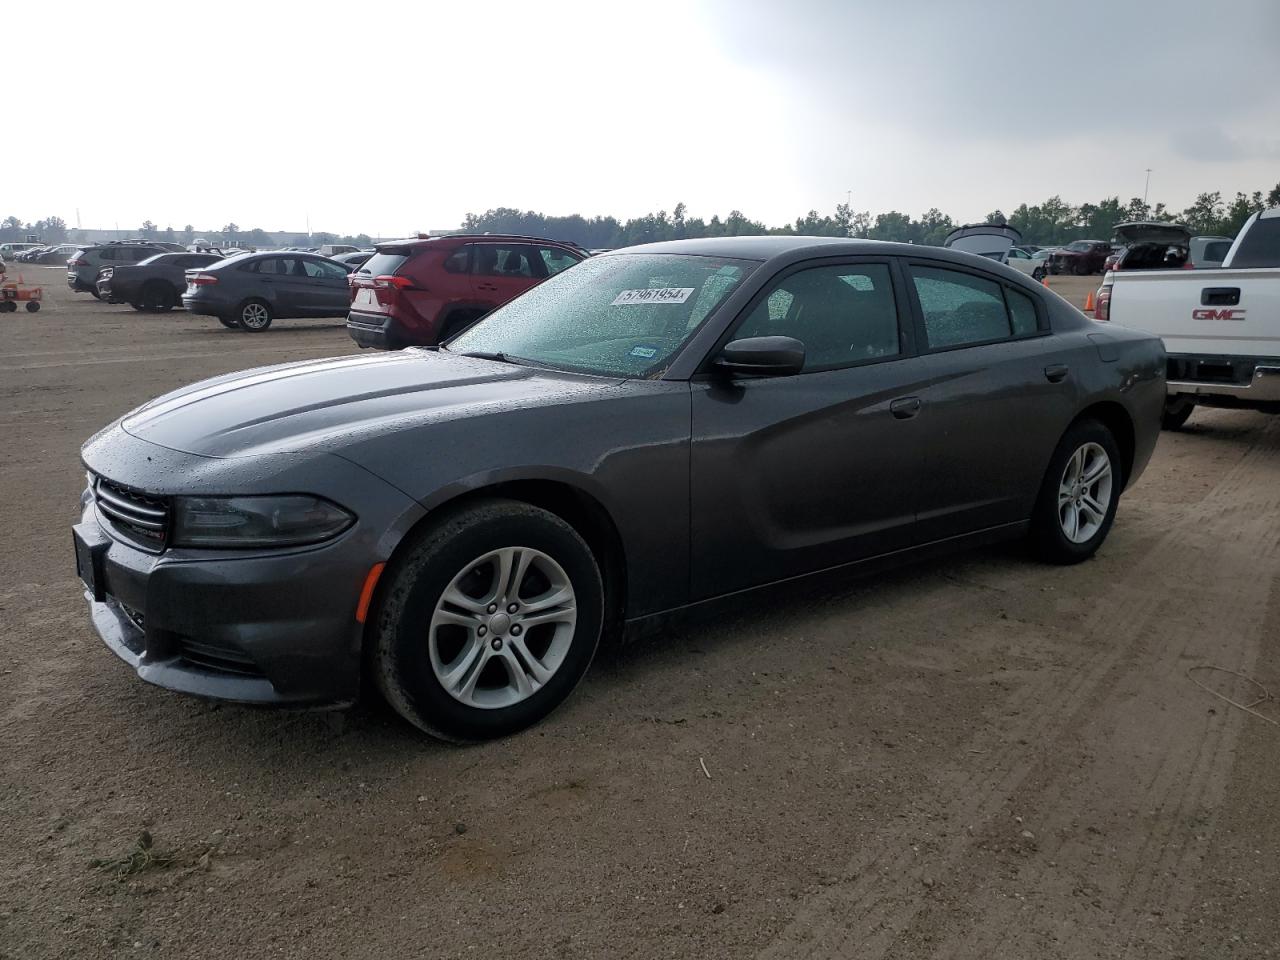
[0,268,1280,960]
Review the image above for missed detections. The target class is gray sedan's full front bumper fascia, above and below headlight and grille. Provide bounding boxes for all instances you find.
[73,424,424,707]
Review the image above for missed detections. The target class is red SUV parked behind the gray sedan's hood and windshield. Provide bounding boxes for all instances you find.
[347,234,586,349]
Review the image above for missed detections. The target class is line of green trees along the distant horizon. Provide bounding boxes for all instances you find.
[0,183,1280,250]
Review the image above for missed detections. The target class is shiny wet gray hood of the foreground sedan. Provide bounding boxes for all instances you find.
[120,349,618,457]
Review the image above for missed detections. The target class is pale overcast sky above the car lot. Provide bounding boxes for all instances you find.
[10,0,1280,236]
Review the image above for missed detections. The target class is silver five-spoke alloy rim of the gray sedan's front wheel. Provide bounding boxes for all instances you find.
[428,547,577,709]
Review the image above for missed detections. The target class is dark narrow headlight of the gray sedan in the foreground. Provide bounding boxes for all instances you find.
[170,495,356,547]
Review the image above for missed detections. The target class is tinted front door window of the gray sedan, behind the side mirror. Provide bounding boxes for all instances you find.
[733,264,899,371]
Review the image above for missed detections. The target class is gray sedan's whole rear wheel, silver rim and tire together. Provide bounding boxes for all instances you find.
[1032,420,1124,564]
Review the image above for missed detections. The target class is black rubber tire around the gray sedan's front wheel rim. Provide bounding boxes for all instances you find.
[369,499,604,742]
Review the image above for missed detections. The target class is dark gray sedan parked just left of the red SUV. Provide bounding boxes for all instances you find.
[182,251,351,333]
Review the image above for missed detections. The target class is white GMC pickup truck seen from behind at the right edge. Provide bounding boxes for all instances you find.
[1108,207,1280,430]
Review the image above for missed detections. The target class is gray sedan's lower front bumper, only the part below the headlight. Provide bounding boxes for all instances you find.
[74,512,367,705]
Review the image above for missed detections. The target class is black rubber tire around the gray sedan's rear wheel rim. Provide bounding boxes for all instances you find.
[1032,420,1124,564]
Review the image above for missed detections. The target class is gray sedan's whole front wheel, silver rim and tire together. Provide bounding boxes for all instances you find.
[371,499,604,742]
